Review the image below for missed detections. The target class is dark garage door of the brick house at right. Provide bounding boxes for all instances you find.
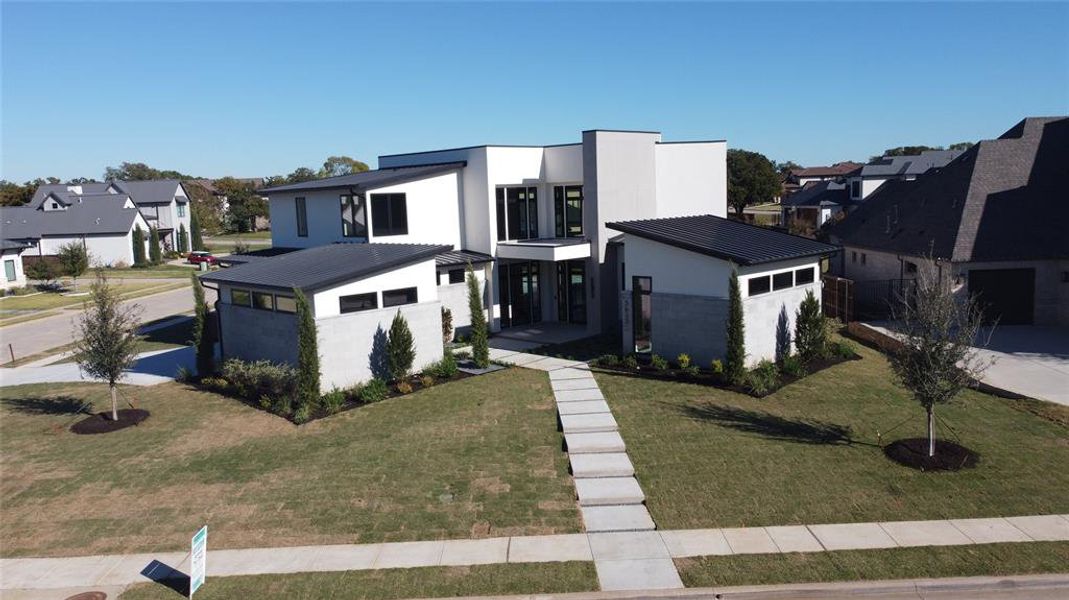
[969,268,1036,325]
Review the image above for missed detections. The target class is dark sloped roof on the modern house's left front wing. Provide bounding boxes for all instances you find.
[201,243,452,291]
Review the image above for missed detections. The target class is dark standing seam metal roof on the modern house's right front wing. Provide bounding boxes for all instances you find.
[605,215,839,265]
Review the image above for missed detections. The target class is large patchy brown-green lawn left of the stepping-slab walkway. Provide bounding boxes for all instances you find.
[0,369,580,556]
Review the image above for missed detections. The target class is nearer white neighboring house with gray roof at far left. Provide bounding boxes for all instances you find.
[0,193,150,266]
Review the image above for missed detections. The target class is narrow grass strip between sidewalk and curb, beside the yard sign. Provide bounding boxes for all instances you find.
[120,563,598,600]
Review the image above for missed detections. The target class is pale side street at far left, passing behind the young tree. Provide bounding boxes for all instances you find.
[0,288,215,365]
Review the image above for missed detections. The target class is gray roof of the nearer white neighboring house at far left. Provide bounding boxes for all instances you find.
[0,194,139,240]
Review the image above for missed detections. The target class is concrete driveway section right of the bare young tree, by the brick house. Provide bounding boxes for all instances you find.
[978,325,1069,406]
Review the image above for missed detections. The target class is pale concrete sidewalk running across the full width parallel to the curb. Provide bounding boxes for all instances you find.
[0,514,1069,596]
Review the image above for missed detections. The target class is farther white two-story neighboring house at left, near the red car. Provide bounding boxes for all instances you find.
[27,180,190,253]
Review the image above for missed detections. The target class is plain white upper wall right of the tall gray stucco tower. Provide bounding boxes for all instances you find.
[655,141,728,217]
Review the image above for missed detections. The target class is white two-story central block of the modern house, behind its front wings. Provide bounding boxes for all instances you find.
[259,130,727,334]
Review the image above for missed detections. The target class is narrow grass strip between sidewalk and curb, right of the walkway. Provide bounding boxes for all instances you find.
[676,541,1069,587]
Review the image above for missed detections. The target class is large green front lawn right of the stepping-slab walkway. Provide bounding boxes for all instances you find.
[597,348,1069,529]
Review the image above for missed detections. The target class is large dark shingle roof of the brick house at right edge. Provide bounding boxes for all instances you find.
[831,117,1069,262]
